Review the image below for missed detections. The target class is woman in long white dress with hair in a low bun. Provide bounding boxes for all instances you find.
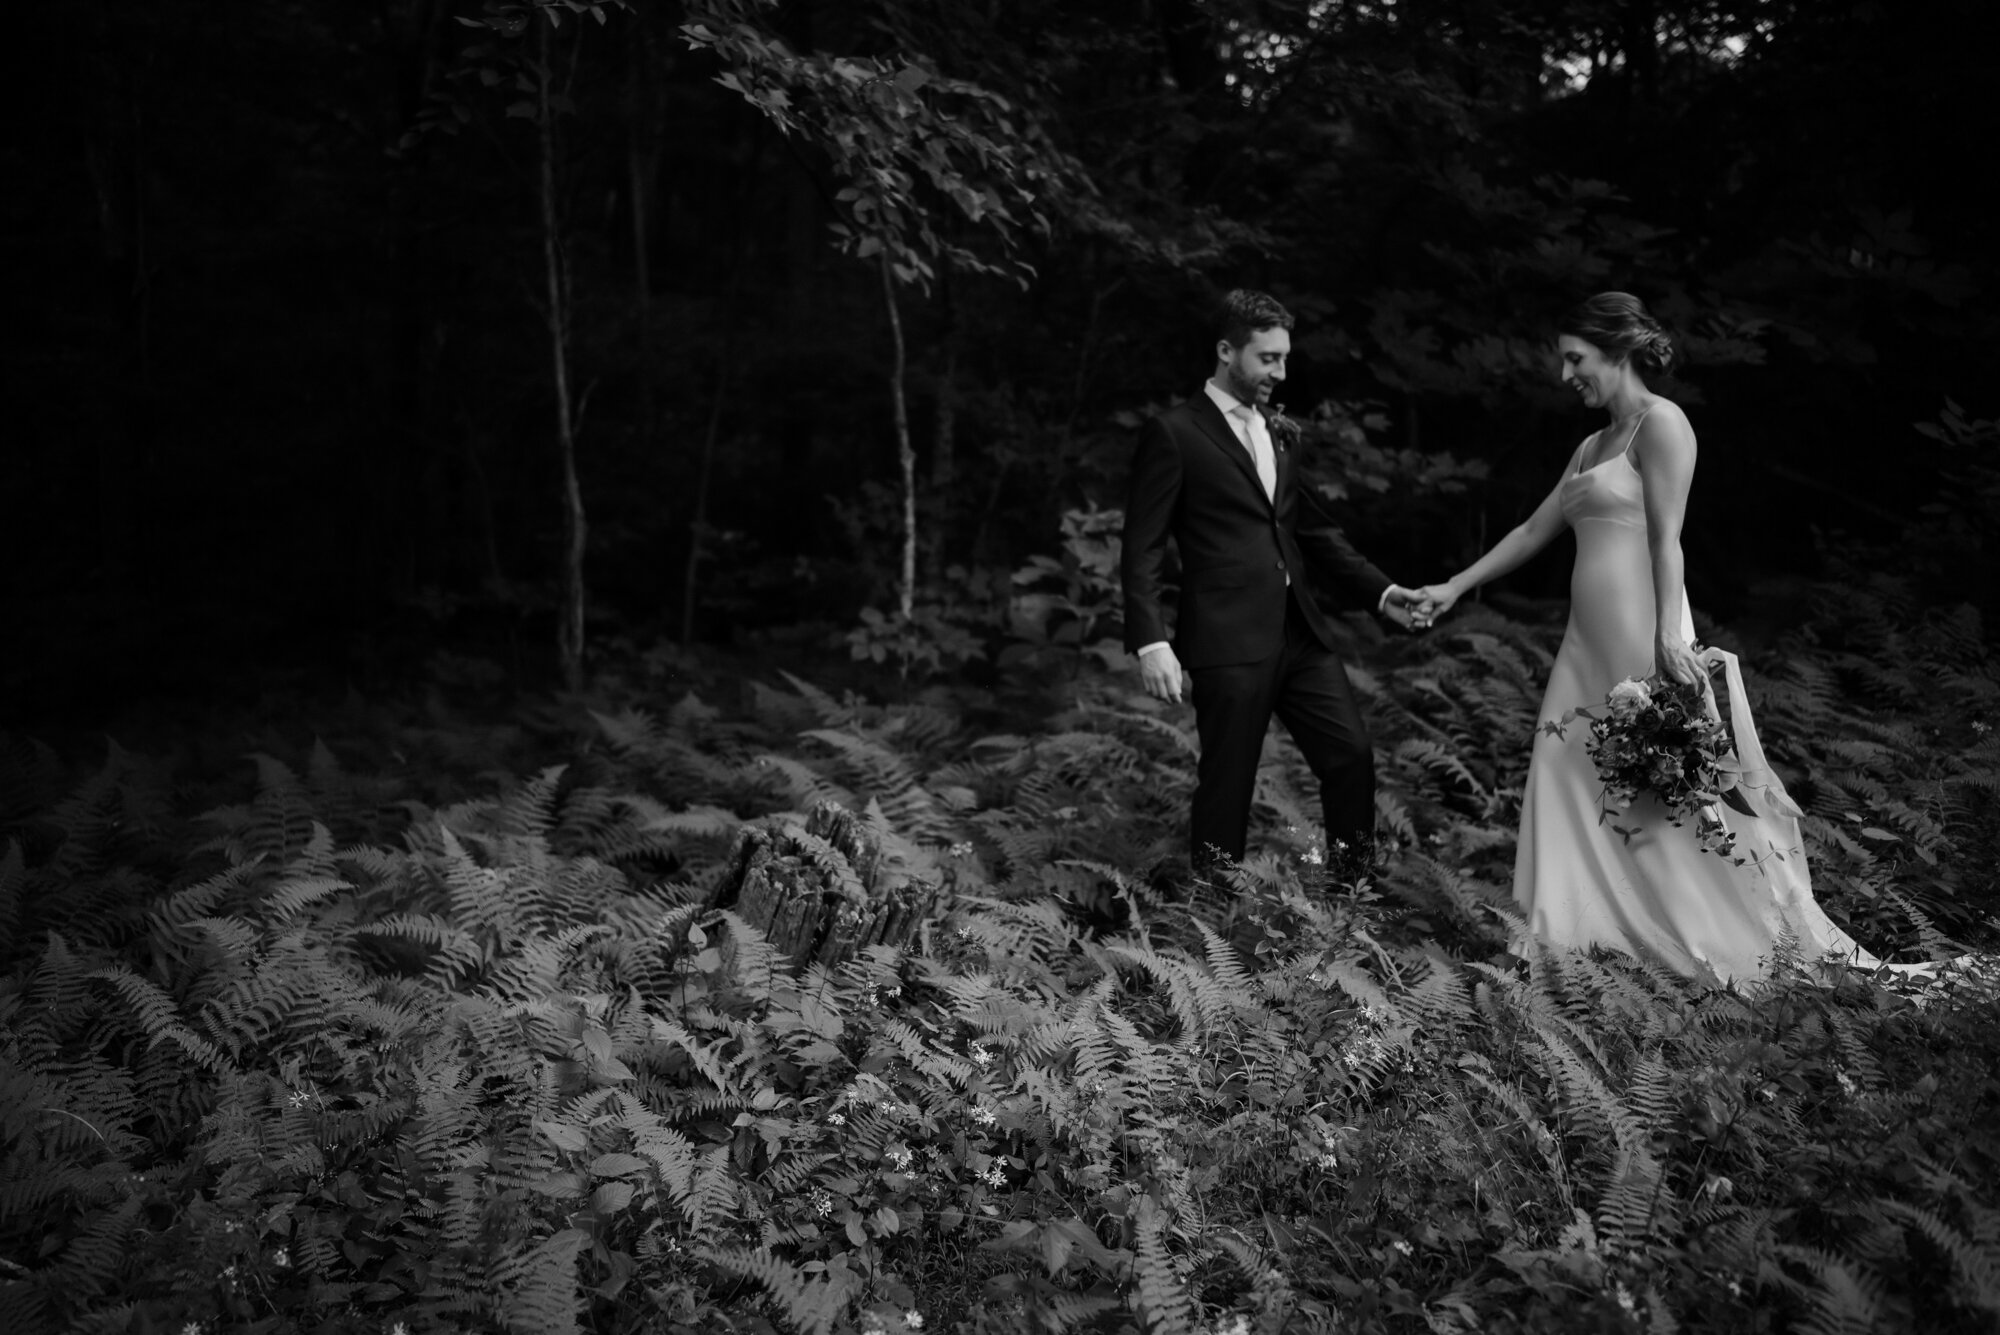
[1418,292,1880,979]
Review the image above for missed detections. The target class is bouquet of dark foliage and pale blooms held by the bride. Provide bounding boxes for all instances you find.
[1546,677,1756,861]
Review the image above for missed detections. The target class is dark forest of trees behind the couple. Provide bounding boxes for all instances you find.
[0,0,2000,721]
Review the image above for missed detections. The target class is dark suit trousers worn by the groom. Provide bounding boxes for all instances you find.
[1188,590,1374,869]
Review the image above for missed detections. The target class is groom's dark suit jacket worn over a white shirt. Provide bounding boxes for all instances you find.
[1122,394,1390,668]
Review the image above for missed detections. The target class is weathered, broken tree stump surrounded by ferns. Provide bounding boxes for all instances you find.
[710,801,948,969]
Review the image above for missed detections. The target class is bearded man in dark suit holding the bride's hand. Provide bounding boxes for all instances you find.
[1124,290,1418,871]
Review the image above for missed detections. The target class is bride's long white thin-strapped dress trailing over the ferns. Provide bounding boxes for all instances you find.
[1514,425,1878,979]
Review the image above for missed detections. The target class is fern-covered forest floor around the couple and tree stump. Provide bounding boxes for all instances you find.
[0,563,2000,1335]
